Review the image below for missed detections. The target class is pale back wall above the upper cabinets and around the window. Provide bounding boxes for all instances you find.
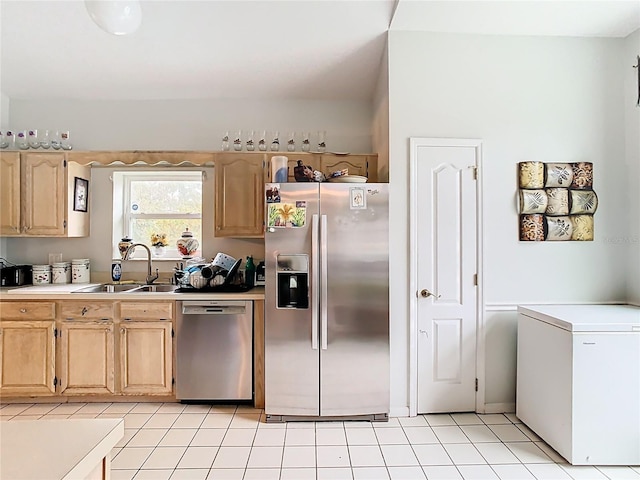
[0,99,372,276]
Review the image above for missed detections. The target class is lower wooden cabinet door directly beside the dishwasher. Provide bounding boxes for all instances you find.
[120,321,173,395]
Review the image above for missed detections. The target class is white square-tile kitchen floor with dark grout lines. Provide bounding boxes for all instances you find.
[0,403,640,480]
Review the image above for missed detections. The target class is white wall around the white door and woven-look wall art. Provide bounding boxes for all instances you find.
[389,31,629,408]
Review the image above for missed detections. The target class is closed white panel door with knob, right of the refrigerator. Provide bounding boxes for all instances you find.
[411,138,480,413]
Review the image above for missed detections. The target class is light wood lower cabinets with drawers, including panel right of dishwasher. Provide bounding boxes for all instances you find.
[0,300,264,408]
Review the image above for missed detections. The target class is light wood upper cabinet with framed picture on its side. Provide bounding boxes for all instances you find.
[0,152,91,237]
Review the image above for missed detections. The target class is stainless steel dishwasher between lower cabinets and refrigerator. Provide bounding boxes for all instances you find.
[176,300,253,400]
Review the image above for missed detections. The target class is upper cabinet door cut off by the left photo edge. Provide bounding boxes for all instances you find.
[0,152,20,236]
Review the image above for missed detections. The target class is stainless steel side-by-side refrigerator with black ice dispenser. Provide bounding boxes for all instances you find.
[265,182,389,421]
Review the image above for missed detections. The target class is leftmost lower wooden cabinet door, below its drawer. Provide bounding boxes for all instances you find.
[0,320,55,396]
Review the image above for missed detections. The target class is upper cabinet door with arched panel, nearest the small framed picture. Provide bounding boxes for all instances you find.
[21,153,67,236]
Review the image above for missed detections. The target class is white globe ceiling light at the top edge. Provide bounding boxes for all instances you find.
[84,0,142,35]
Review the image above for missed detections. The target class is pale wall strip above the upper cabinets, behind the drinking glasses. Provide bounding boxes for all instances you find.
[11,99,372,153]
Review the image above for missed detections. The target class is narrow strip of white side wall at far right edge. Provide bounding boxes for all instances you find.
[619,30,640,305]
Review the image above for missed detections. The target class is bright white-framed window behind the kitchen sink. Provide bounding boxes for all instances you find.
[113,170,203,259]
